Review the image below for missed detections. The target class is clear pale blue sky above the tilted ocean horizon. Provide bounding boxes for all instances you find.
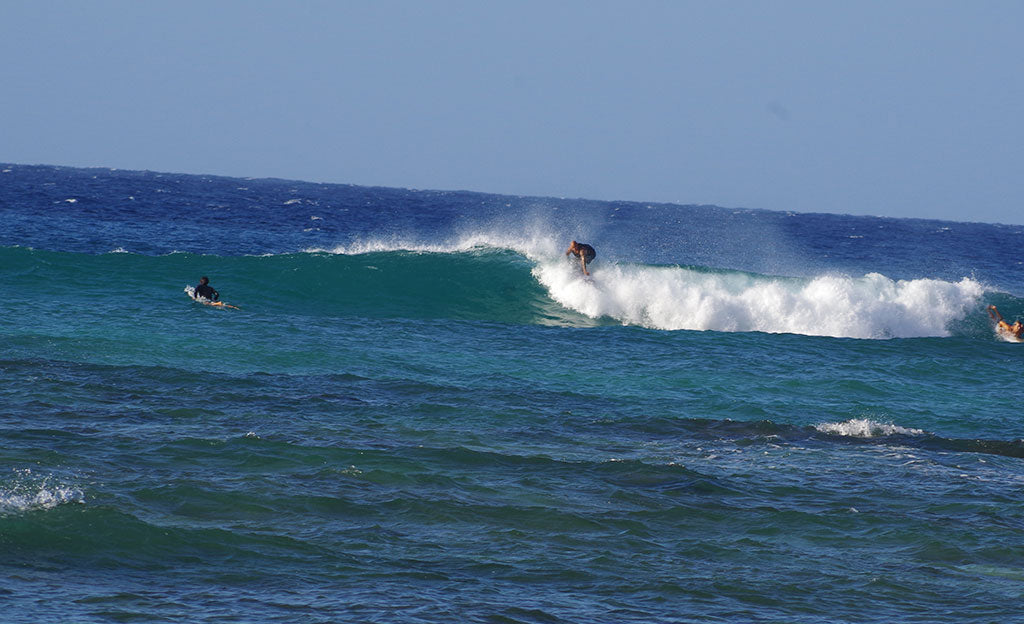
[0,0,1024,223]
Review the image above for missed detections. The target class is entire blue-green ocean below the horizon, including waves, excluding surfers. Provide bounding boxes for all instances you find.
[0,164,1024,624]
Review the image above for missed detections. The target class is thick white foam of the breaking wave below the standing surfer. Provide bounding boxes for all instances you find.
[534,260,984,338]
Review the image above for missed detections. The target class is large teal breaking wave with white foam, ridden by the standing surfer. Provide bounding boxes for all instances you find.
[0,245,1024,339]
